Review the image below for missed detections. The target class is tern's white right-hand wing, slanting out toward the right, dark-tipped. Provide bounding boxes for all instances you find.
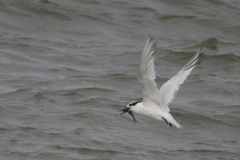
[159,48,203,112]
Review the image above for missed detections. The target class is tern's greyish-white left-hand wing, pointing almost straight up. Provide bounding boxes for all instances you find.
[138,35,160,106]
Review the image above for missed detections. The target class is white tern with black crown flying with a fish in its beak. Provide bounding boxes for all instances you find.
[119,35,203,129]
